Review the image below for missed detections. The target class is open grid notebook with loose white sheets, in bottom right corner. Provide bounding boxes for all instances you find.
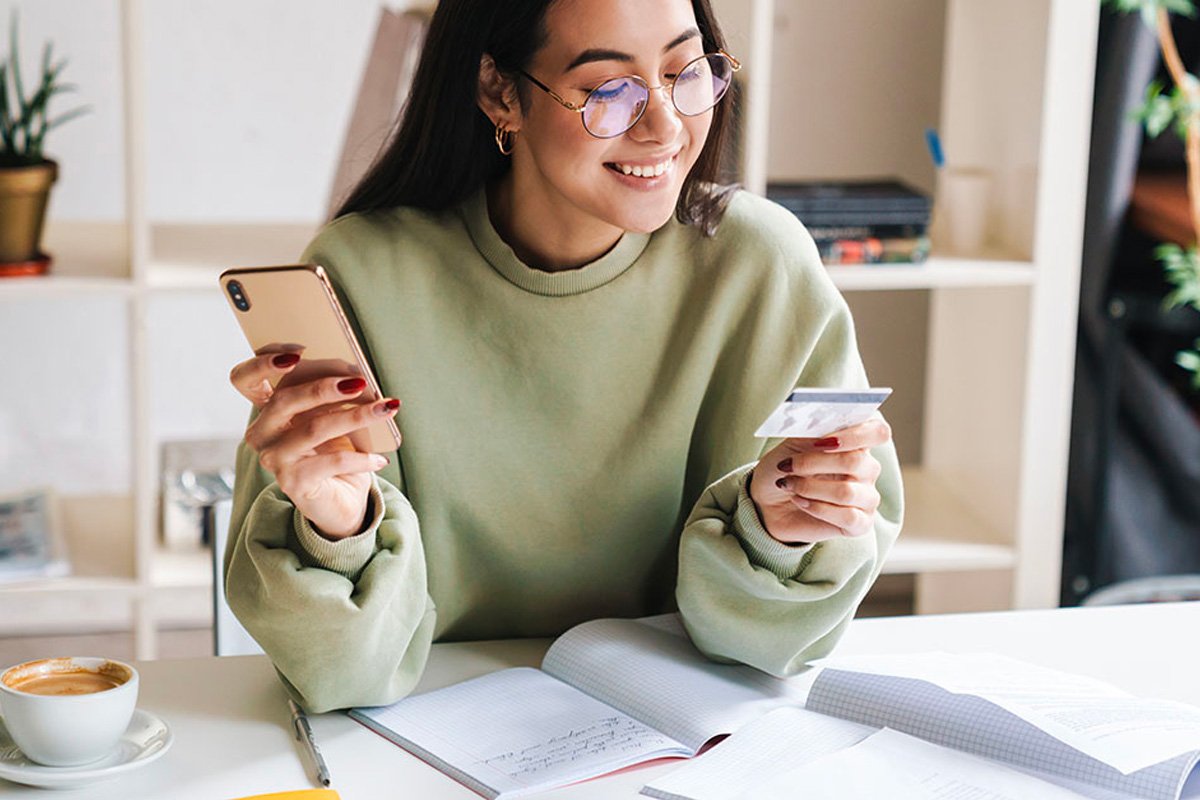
[642,652,1200,800]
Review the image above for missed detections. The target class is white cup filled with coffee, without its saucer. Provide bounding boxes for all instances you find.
[0,657,138,766]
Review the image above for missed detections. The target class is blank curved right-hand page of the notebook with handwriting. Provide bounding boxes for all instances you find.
[541,618,804,750]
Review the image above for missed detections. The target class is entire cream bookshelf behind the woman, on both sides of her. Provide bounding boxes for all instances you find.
[0,0,1098,658]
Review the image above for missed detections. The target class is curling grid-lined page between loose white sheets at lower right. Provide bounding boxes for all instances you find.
[808,667,1198,800]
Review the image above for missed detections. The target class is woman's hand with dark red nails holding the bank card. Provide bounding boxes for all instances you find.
[750,417,892,545]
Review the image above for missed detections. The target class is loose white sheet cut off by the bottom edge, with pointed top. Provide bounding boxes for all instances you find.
[737,730,1099,800]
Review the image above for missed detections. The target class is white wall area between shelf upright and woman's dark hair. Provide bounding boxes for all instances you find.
[144,0,379,222]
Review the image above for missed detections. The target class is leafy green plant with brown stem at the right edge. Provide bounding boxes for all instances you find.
[1102,0,1200,391]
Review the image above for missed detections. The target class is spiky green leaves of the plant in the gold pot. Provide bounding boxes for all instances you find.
[0,11,89,168]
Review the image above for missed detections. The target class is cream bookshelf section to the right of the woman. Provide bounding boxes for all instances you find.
[716,0,1099,612]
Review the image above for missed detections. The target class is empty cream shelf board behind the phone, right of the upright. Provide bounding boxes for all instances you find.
[146,222,319,290]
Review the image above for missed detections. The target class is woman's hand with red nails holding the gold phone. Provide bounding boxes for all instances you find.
[229,353,400,540]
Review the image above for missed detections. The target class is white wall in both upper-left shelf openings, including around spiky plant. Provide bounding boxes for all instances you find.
[0,0,379,222]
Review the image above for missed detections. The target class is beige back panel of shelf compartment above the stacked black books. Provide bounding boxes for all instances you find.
[768,0,945,191]
